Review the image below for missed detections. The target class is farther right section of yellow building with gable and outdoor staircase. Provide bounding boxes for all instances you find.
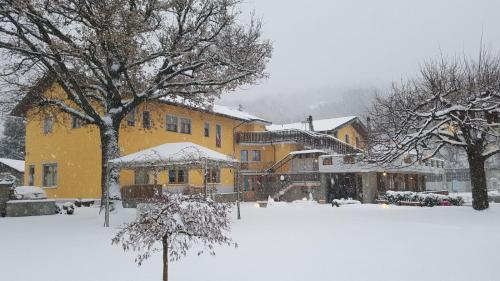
[237,116,366,197]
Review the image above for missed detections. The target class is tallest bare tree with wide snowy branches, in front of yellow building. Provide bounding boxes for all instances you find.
[0,0,272,199]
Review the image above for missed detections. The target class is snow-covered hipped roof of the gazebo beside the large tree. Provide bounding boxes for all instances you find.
[110,142,238,166]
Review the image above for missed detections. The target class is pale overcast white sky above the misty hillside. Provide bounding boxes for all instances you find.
[223,0,500,103]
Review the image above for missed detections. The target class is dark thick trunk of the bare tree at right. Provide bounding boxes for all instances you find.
[467,149,489,210]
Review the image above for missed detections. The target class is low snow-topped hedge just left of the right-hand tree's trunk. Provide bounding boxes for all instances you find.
[382,191,464,207]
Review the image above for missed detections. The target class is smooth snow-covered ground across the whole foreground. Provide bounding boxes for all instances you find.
[0,202,500,281]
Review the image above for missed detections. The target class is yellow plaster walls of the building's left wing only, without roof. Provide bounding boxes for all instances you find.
[25,82,265,198]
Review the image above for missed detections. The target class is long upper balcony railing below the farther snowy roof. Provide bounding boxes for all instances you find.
[236,129,361,154]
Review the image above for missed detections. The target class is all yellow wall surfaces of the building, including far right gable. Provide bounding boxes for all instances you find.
[21,81,364,198]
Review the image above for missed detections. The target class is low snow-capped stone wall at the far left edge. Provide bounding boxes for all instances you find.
[7,199,56,217]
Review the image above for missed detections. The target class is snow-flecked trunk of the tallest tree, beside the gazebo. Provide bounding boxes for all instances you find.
[100,122,121,205]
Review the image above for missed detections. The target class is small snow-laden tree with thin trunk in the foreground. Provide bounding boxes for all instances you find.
[112,193,236,281]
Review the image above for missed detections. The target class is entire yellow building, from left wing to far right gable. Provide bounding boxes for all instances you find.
[13,80,364,199]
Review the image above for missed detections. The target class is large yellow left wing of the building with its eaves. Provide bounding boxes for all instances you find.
[13,81,270,198]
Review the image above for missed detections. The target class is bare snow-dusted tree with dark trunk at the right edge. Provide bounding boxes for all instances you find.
[370,50,500,210]
